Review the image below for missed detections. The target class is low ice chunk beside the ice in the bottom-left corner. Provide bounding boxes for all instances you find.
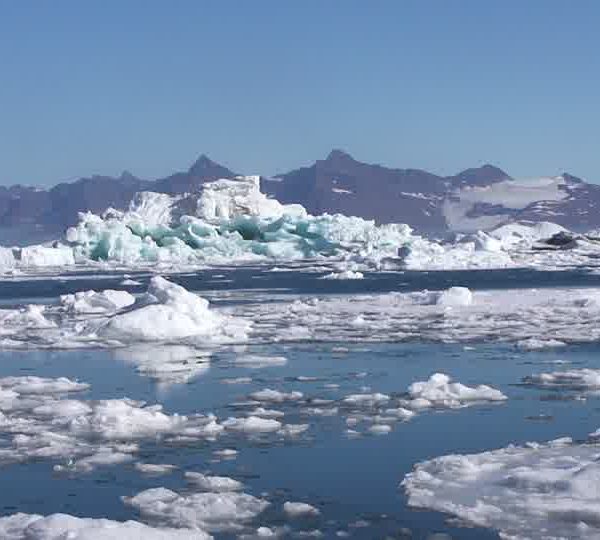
[123,488,269,532]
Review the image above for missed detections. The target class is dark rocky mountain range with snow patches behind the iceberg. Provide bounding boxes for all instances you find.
[0,150,600,244]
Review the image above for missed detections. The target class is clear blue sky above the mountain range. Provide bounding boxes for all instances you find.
[0,0,600,185]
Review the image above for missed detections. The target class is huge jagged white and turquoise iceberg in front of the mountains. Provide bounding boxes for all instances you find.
[0,176,600,279]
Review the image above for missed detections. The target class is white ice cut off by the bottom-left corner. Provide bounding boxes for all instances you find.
[0,514,212,540]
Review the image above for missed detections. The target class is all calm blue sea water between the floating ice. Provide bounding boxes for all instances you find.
[0,268,600,540]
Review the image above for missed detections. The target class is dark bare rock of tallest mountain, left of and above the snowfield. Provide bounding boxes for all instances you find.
[264,150,509,231]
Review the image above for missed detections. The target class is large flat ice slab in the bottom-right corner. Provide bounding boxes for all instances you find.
[402,439,600,540]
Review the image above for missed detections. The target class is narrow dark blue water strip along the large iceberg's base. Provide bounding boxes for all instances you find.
[0,266,600,304]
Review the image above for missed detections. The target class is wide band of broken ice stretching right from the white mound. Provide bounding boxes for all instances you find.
[235,287,600,349]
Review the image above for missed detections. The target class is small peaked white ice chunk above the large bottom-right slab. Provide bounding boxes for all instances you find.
[408,373,507,408]
